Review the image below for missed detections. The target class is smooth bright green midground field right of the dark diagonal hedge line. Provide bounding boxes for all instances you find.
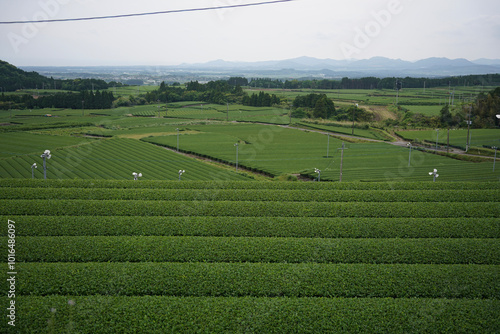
[142,124,500,181]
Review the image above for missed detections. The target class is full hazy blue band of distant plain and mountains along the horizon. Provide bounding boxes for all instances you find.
[17,57,500,82]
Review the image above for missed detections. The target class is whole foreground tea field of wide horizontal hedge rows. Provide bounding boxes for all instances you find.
[0,180,500,333]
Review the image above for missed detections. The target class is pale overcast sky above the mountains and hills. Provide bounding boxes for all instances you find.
[0,0,500,66]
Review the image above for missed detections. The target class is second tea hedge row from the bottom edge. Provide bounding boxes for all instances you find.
[12,263,500,299]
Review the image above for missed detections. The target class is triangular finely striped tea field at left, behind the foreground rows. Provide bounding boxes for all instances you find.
[0,138,248,180]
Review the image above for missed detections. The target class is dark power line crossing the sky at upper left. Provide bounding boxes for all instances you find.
[0,0,297,24]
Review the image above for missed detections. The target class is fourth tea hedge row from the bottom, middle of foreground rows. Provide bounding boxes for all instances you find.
[0,216,500,238]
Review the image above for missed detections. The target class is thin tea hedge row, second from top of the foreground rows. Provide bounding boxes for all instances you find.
[0,188,500,202]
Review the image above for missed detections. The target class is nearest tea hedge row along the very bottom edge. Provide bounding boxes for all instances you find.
[0,296,500,334]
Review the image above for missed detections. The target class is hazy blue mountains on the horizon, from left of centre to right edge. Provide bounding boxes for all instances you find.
[176,57,500,77]
